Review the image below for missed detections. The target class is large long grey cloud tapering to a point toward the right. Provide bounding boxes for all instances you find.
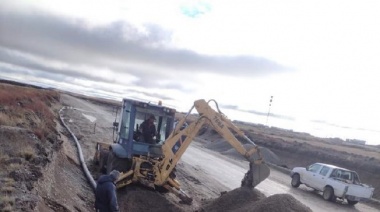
[0,9,286,80]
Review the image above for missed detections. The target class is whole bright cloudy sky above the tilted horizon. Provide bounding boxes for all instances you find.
[0,0,380,144]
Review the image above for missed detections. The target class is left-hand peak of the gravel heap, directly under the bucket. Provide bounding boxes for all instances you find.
[203,188,265,212]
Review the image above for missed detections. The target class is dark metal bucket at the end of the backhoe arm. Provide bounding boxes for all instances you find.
[241,162,270,188]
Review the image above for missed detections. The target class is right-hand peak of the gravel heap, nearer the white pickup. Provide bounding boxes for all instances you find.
[237,194,312,212]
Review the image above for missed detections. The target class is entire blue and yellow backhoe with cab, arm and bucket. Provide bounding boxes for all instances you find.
[94,99,270,204]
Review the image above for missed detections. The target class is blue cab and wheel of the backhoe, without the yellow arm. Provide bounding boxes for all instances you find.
[95,99,176,174]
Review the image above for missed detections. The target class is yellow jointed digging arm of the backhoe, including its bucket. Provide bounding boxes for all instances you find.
[155,99,270,192]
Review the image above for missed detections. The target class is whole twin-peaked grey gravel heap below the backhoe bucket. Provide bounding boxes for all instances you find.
[203,188,312,212]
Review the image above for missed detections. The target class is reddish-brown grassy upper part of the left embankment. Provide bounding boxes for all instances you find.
[0,84,60,211]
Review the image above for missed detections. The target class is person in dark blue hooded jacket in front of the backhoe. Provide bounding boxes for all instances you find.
[95,170,120,212]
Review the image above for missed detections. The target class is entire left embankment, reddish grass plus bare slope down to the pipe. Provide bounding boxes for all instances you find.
[0,84,93,211]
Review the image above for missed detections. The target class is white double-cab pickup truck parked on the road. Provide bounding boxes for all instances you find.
[290,163,374,205]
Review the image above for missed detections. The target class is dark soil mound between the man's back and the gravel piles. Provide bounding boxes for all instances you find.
[117,185,183,212]
